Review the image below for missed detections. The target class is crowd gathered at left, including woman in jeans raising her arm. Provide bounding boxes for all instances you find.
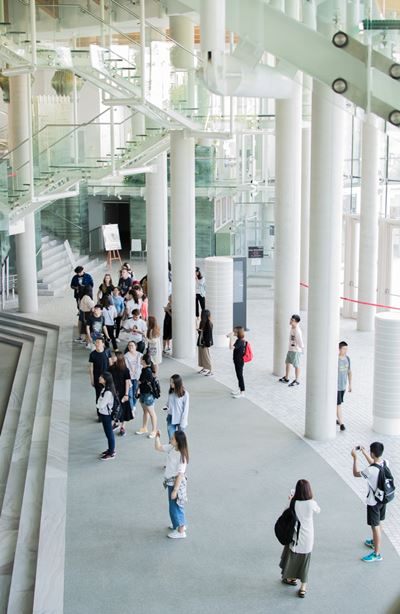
[71,263,189,539]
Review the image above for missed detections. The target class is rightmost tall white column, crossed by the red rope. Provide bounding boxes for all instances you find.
[357,115,379,331]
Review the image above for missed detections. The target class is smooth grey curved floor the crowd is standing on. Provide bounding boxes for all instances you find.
[65,345,400,614]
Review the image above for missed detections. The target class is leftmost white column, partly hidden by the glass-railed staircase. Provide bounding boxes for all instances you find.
[8,75,38,313]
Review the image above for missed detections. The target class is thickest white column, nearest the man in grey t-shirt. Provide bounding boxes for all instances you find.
[306,81,345,440]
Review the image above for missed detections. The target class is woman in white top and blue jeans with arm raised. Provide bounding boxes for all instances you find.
[155,431,189,539]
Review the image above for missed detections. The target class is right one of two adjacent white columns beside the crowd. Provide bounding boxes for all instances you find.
[170,131,196,358]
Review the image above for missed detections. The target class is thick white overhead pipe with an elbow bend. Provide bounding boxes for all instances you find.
[198,0,294,98]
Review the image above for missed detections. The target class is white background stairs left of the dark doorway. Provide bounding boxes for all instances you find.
[38,236,106,296]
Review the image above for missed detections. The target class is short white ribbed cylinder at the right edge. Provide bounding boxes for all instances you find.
[372,312,400,435]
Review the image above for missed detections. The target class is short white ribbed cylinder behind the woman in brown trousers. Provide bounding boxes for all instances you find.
[205,256,233,347]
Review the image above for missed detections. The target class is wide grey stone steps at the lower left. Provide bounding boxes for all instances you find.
[0,313,72,614]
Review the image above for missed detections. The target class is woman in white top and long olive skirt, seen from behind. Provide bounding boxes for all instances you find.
[279,480,321,597]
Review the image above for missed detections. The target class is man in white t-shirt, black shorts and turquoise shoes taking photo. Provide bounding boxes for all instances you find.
[351,441,387,563]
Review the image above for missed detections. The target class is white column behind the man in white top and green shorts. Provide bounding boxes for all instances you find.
[273,85,302,375]
